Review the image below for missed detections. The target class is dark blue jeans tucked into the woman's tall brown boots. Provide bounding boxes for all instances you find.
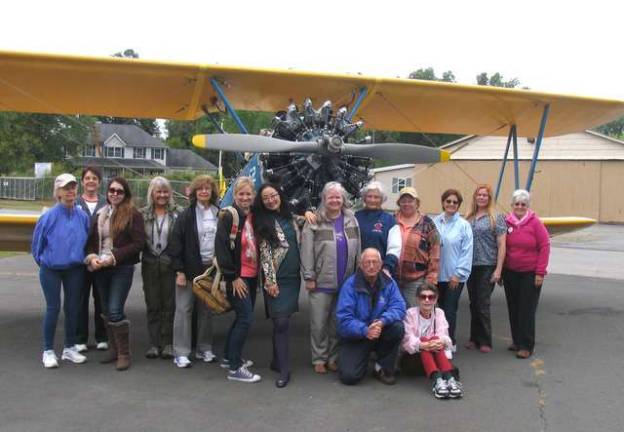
[94,264,134,322]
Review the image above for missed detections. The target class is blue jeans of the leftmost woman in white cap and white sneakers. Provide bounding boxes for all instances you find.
[39,265,85,350]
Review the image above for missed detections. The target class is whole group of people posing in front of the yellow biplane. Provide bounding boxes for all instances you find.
[32,167,549,398]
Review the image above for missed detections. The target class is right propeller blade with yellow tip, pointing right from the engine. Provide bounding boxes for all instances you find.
[342,143,451,163]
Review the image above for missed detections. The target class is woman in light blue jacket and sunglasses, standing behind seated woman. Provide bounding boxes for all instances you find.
[433,189,472,349]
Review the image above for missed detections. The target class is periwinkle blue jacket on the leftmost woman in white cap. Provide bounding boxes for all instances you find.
[31,204,89,270]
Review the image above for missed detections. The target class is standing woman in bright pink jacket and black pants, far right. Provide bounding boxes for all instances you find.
[503,189,550,359]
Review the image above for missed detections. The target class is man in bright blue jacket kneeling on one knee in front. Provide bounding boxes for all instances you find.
[336,248,405,384]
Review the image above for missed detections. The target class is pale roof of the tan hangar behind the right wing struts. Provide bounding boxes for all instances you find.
[443,131,624,160]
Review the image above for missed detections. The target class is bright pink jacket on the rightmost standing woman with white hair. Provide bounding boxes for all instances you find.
[504,210,550,276]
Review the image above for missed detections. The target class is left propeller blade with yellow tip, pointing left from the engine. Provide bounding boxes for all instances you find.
[193,134,321,153]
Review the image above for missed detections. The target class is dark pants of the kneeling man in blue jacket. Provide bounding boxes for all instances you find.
[338,321,404,385]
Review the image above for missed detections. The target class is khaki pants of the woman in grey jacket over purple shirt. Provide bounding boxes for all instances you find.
[309,291,338,364]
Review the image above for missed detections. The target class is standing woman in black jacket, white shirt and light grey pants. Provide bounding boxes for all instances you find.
[167,175,219,368]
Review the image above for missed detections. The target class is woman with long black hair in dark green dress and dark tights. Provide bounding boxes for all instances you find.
[252,182,301,388]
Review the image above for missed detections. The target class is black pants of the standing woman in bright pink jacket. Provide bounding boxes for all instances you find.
[503,270,542,352]
